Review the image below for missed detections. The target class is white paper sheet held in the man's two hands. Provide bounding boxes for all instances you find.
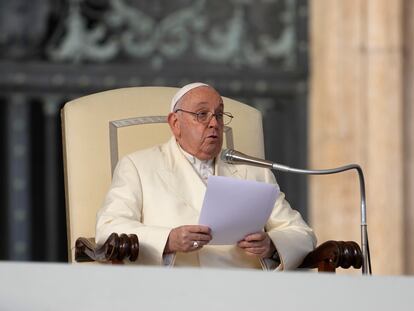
[199,176,279,245]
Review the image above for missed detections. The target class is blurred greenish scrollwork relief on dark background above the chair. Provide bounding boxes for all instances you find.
[43,0,297,70]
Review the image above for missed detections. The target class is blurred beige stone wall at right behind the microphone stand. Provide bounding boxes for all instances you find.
[309,0,414,274]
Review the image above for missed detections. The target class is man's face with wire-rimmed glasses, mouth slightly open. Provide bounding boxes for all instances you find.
[168,86,224,160]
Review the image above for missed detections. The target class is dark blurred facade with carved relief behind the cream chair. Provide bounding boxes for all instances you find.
[0,0,308,261]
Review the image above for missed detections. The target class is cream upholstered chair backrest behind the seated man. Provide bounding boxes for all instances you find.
[61,87,264,262]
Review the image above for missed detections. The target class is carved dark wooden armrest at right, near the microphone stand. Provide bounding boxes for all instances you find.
[299,241,362,272]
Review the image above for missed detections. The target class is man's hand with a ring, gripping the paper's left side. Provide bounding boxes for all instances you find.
[164,225,212,253]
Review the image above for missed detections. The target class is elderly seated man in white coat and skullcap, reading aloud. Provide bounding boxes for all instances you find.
[96,83,316,270]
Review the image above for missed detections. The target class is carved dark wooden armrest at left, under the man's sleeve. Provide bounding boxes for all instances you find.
[75,233,139,263]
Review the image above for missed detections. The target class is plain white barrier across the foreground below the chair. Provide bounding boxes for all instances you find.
[0,262,414,311]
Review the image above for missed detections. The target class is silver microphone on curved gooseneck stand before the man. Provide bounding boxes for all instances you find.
[220,149,372,274]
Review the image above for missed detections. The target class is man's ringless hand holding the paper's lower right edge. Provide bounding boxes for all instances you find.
[237,232,276,258]
